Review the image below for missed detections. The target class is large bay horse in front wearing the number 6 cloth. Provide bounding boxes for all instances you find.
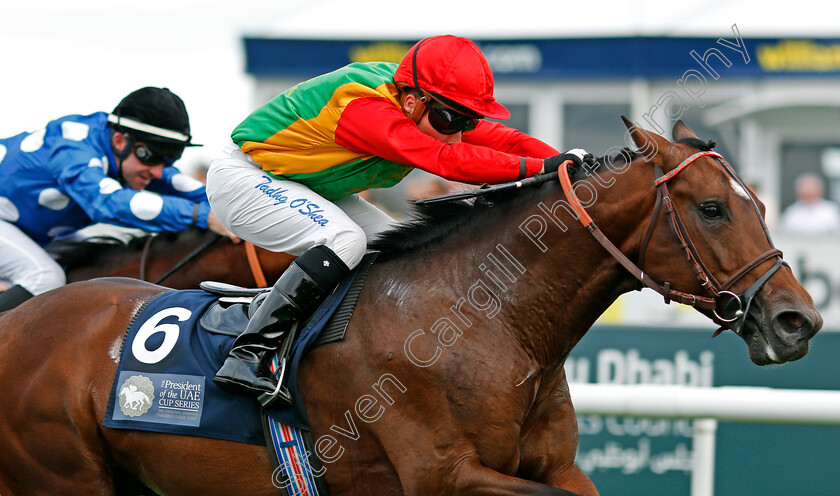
[0,121,822,496]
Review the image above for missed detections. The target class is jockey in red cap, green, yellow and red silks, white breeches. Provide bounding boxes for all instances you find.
[207,36,585,400]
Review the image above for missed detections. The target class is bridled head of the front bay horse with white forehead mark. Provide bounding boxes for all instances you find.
[624,119,822,365]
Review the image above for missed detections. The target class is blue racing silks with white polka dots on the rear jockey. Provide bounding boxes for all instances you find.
[0,112,210,245]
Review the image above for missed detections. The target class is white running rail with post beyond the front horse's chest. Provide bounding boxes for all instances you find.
[569,383,840,496]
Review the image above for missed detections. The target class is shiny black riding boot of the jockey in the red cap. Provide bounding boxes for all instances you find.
[213,246,350,395]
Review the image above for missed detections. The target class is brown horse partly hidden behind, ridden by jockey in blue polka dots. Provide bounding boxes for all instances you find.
[59,228,294,289]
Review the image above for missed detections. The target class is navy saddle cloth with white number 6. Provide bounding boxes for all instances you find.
[103,256,367,445]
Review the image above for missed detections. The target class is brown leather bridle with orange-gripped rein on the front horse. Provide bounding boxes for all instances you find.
[559,151,787,336]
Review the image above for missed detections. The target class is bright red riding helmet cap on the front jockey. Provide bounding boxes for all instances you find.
[394,35,510,119]
